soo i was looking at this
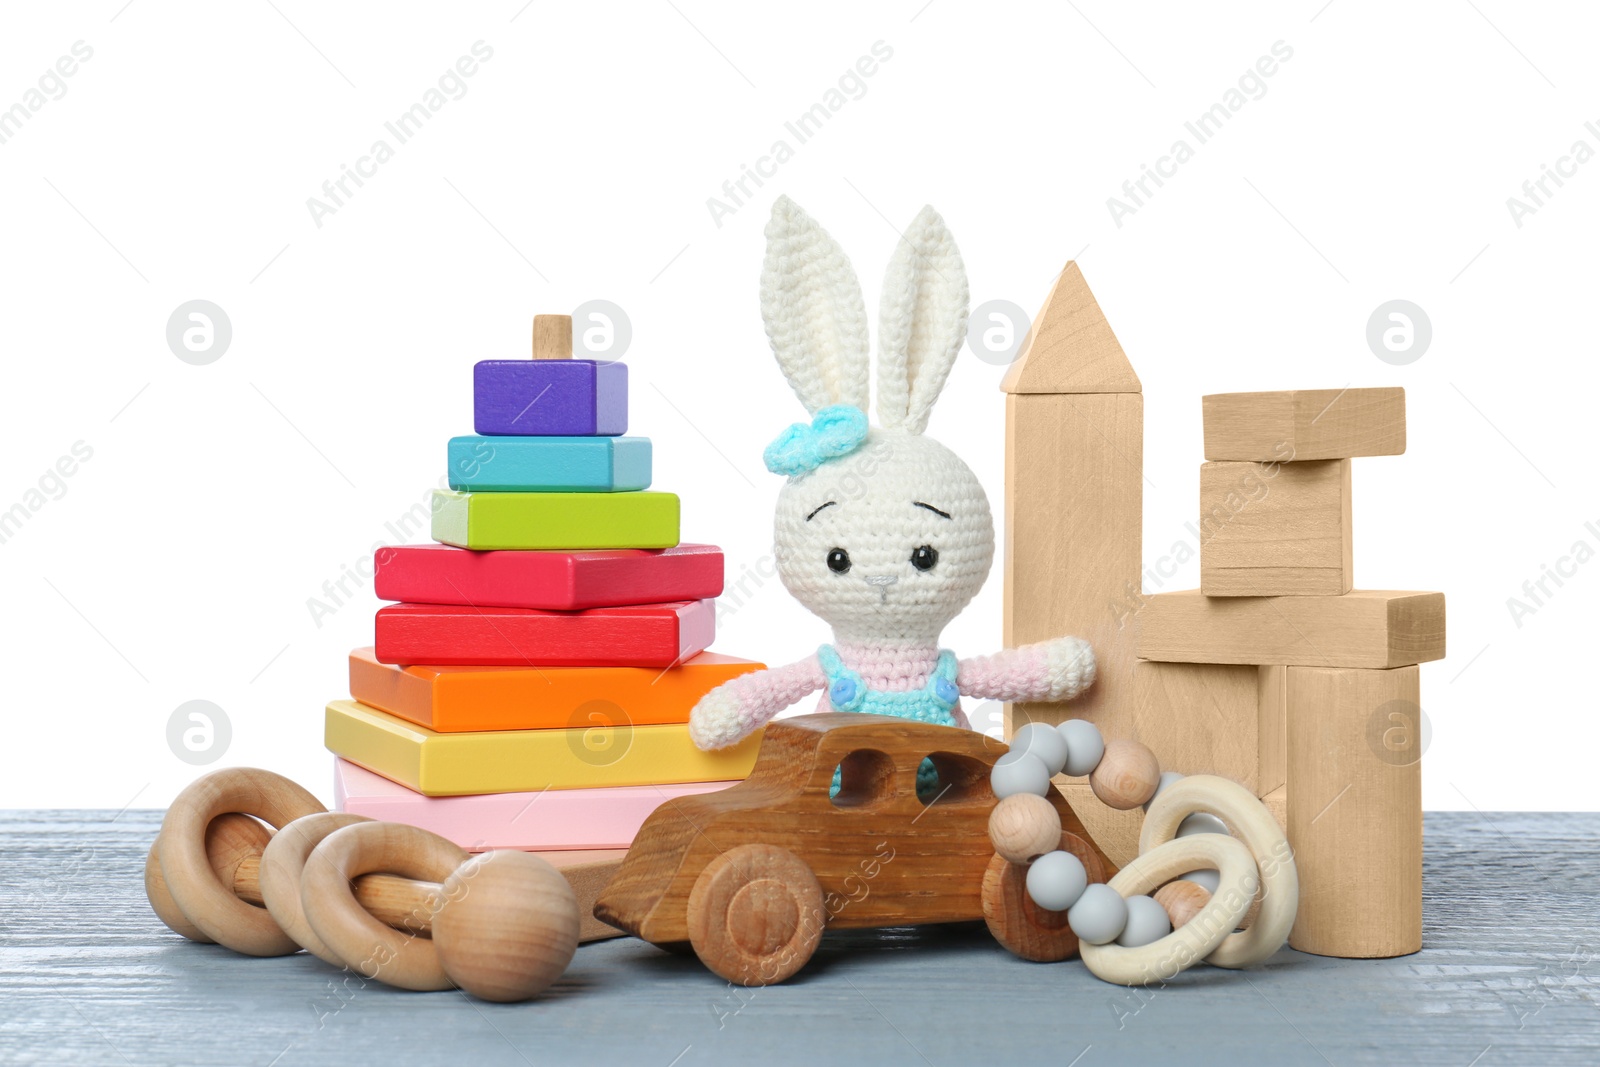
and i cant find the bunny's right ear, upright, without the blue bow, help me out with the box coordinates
[878,205,966,434]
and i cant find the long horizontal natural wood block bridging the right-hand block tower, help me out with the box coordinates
[1139,589,1445,667]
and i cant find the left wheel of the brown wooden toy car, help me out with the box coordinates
[688,845,826,985]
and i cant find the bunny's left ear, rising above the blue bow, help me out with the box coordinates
[762,197,867,414]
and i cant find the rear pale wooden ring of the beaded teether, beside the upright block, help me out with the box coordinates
[1139,774,1299,968]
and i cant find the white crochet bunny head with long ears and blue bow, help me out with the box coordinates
[762,197,994,646]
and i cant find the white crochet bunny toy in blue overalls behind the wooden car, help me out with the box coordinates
[690,197,1094,758]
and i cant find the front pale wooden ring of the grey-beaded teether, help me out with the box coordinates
[1078,833,1259,985]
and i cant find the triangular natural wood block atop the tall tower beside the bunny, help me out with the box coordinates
[1000,262,1141,394]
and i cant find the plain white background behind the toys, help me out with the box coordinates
[0,0,1600,811]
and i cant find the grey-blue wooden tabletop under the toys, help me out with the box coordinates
[0,811,1600,1067]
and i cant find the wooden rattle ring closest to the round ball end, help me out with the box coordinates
[301,822,469,990]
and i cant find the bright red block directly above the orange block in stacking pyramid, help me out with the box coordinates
[374,600,717,667]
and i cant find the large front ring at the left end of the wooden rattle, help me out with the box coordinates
[155,768,323,957]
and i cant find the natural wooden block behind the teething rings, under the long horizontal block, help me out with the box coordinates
[1126,659,1262,797]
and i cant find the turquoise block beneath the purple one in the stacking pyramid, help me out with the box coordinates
[445,437,651,493]
